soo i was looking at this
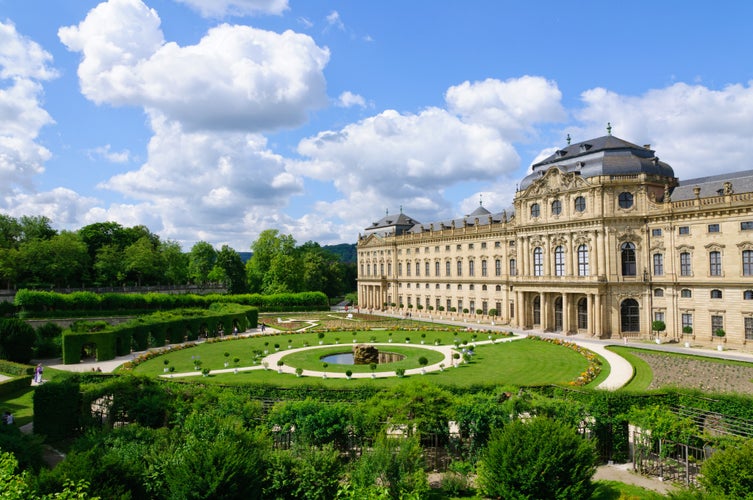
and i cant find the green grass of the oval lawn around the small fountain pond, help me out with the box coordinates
[134,331,592,388]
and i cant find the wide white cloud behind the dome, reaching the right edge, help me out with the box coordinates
[571,83,753,180]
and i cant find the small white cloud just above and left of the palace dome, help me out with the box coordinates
[445,76,567,140]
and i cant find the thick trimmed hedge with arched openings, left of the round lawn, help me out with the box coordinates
[63,304,259,364]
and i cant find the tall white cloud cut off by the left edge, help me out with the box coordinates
[0,22,57,199]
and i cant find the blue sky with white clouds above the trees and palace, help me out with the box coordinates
[0,0,753,251]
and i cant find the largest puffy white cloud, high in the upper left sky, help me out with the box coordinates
[58,0,329,132]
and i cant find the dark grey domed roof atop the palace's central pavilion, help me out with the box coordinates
[520,135,675,189]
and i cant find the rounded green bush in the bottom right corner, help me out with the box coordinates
[699,439,753,500]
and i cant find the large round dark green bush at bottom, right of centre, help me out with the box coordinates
[478,417,597,499]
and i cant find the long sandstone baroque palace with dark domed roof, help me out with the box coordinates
[358,129,753,345]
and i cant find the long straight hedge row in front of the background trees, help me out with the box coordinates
[14,289,329,317]
